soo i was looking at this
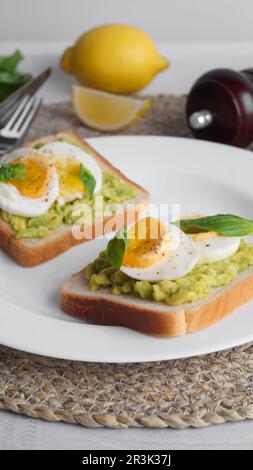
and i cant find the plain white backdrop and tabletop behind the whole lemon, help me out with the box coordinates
[0,0,253,102]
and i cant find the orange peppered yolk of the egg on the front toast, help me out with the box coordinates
[123,217,172,268]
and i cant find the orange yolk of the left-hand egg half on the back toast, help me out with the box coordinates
[10,152,53,199]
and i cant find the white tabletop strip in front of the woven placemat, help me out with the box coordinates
[0,411,253,450]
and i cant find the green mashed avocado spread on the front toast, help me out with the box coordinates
[84,241,253,306]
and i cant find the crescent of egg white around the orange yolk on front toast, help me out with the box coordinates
[120,227,199,282]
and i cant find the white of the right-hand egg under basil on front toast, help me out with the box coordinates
[195,236,241,263]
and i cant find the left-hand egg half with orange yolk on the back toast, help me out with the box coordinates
[0,148,59,217]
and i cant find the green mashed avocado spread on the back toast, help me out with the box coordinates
[0,138,135,239]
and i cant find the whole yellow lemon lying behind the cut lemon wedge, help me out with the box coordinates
[61,24,169,94]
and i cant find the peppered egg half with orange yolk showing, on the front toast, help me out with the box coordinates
[120,217,199,282]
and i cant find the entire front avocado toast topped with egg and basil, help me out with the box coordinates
[60,214,253,336]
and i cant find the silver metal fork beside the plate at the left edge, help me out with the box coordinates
[0,95,42,157]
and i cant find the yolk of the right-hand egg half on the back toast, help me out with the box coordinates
[51,157,84,199]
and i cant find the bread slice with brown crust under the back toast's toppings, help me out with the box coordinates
[0,132,149,267]
